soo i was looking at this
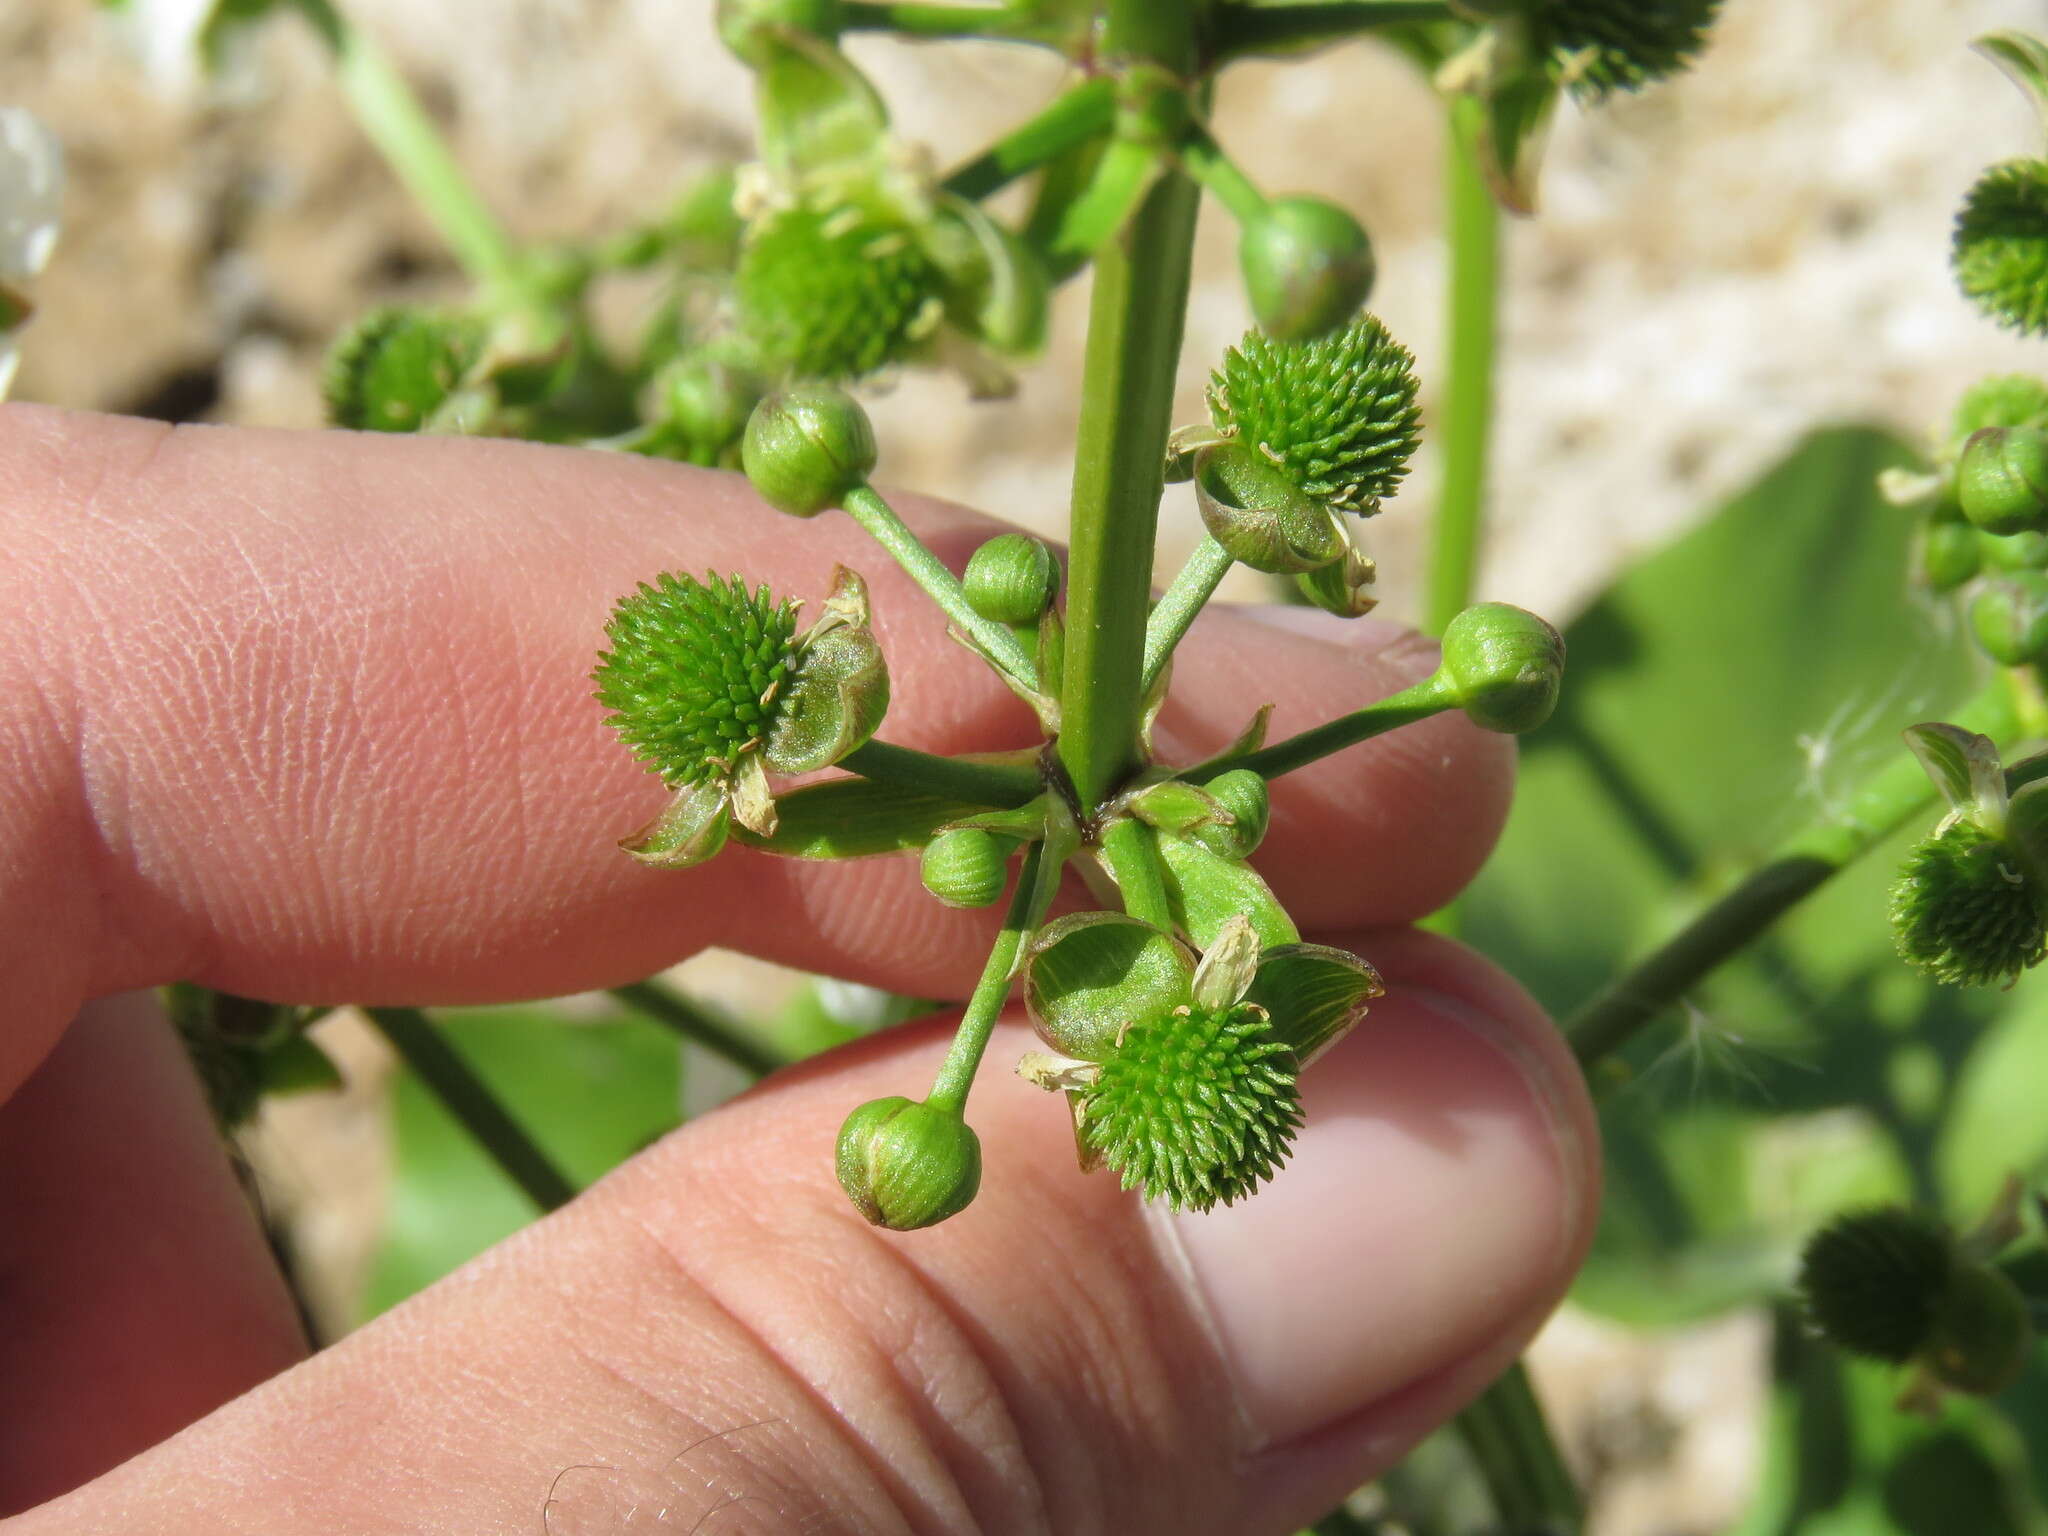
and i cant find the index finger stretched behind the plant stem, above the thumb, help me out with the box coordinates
[0,406,1511,1094]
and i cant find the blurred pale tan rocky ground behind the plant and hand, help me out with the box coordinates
[0,0,2048,1536]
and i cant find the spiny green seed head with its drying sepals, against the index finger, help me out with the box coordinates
[594,569,889,868]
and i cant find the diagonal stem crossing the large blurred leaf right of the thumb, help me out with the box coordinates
[1565,678,2019,1067]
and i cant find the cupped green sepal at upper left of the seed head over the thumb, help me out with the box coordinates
[1024,911,1196,1061]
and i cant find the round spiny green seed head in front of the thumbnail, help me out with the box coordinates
[1079,1006,1300,1210]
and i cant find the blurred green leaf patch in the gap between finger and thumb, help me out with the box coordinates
[362,1004,682,1317]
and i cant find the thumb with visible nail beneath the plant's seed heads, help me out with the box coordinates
[18,934,1597,1536]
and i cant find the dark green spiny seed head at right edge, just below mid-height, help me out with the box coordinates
[1890,821,2048,987]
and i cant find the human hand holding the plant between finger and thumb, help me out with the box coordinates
[0,408,1597,1536]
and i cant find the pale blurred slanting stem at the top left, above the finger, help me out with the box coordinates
[295,0,522,293]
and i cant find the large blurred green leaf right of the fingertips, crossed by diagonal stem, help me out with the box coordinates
[1464,430,2015,1323]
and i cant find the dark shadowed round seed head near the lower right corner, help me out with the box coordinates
[1798,1206,1954,1364]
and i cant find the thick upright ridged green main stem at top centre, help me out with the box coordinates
[1059,0,1206,811]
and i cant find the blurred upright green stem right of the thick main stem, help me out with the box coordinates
[1423,96,1501,635]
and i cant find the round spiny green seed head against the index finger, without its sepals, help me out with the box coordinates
[594,573,801,788]
